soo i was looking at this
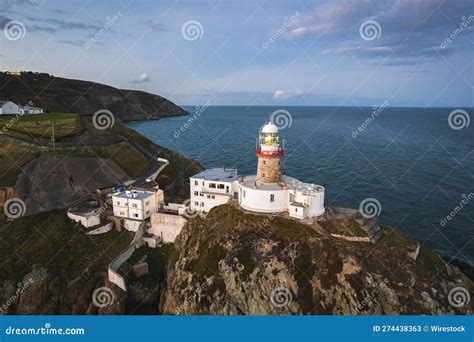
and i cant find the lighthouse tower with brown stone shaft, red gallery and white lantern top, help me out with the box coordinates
[256,122,283,183]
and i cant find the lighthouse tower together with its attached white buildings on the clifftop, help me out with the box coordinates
[190,122,324,219]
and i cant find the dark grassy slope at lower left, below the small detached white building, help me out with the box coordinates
[0,211,132,283]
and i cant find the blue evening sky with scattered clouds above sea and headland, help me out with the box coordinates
[0,0,474,107]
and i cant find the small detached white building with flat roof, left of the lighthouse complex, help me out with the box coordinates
[112,190,164,221]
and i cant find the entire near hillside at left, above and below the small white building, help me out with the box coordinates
[0,113,202,315]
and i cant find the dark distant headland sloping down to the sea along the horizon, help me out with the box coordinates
[0,72,187,122]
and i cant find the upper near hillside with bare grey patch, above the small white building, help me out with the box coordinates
[0,114,202,222]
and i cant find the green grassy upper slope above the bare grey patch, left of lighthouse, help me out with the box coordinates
[0,114,202,191]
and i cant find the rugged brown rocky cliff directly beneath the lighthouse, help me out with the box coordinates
[163,205,474,315]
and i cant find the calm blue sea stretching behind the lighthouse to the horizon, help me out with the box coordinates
[129,106,474,264]
